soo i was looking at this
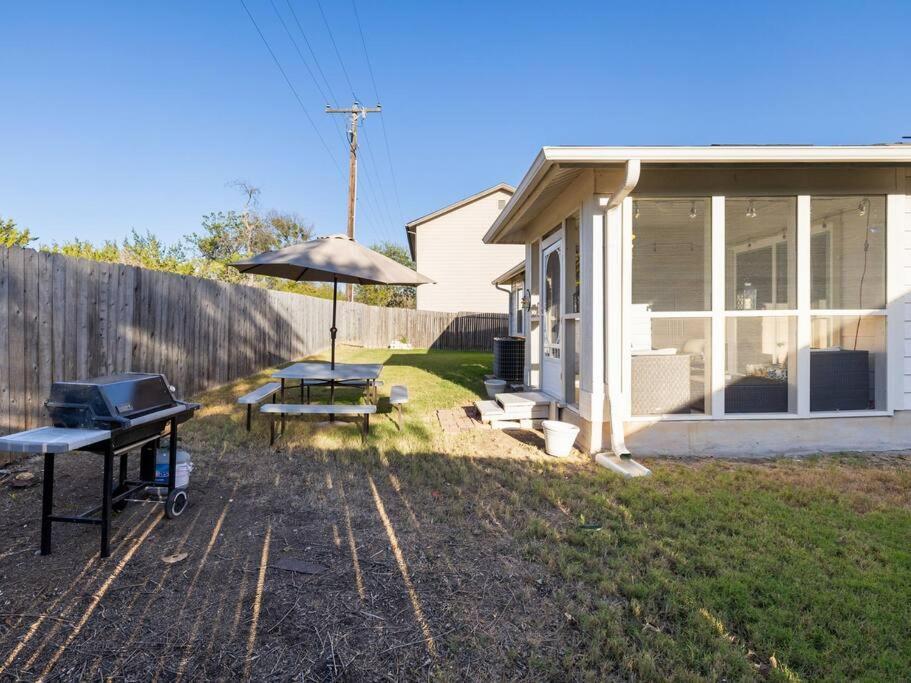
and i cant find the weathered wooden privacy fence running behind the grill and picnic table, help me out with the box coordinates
[0,247,507,434]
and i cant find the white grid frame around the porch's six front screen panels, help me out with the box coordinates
[621,194,896,422]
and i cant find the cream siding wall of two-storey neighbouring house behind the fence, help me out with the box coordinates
[415,192,525,313]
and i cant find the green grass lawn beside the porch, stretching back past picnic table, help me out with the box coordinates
[188,348,911,681]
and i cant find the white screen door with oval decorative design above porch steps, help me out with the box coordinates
[541,231,563,399]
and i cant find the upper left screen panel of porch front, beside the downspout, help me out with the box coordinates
[632,198,712,311]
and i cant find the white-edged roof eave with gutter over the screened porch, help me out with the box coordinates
[484,143,911,243]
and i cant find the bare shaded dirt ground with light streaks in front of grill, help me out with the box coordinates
[0,416,584,681]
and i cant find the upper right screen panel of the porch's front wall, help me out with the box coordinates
[810,196,886,309]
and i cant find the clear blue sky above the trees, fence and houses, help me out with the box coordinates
[0,0,911,252]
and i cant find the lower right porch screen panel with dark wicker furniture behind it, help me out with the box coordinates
[810,315,886,411]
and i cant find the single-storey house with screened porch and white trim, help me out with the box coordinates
[484,144,911,455]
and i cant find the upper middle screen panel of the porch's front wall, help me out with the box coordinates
[724,197,797,311]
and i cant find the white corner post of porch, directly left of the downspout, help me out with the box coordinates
[579,197,605,453]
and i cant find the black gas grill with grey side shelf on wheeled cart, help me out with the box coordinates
[0,372,200,557]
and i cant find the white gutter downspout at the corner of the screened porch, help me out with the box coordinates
[598,159,642,460]
